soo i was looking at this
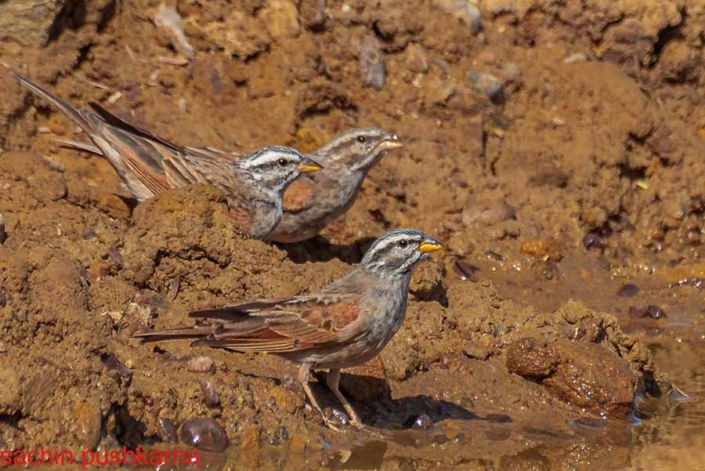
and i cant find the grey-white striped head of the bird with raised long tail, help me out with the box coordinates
[235,146,323,193]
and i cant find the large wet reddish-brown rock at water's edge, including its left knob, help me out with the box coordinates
[507,338,637,417]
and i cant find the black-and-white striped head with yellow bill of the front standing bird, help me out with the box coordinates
[360,229,443,278]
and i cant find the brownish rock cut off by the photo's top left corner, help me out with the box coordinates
[0,0,74,47]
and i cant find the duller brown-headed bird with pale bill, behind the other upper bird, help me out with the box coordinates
[268,128,403,243]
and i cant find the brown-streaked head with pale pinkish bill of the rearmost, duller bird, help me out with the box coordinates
[314,128,402,172]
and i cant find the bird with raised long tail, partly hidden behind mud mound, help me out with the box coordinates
[11,72,323,239]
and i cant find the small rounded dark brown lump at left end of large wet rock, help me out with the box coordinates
[507,337,560,379]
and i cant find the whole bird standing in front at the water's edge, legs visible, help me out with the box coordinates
[133,229,444,429]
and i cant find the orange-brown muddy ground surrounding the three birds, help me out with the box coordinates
[0,0,705,470]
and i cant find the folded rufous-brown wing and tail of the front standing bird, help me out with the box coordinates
[138,295,360,353]
